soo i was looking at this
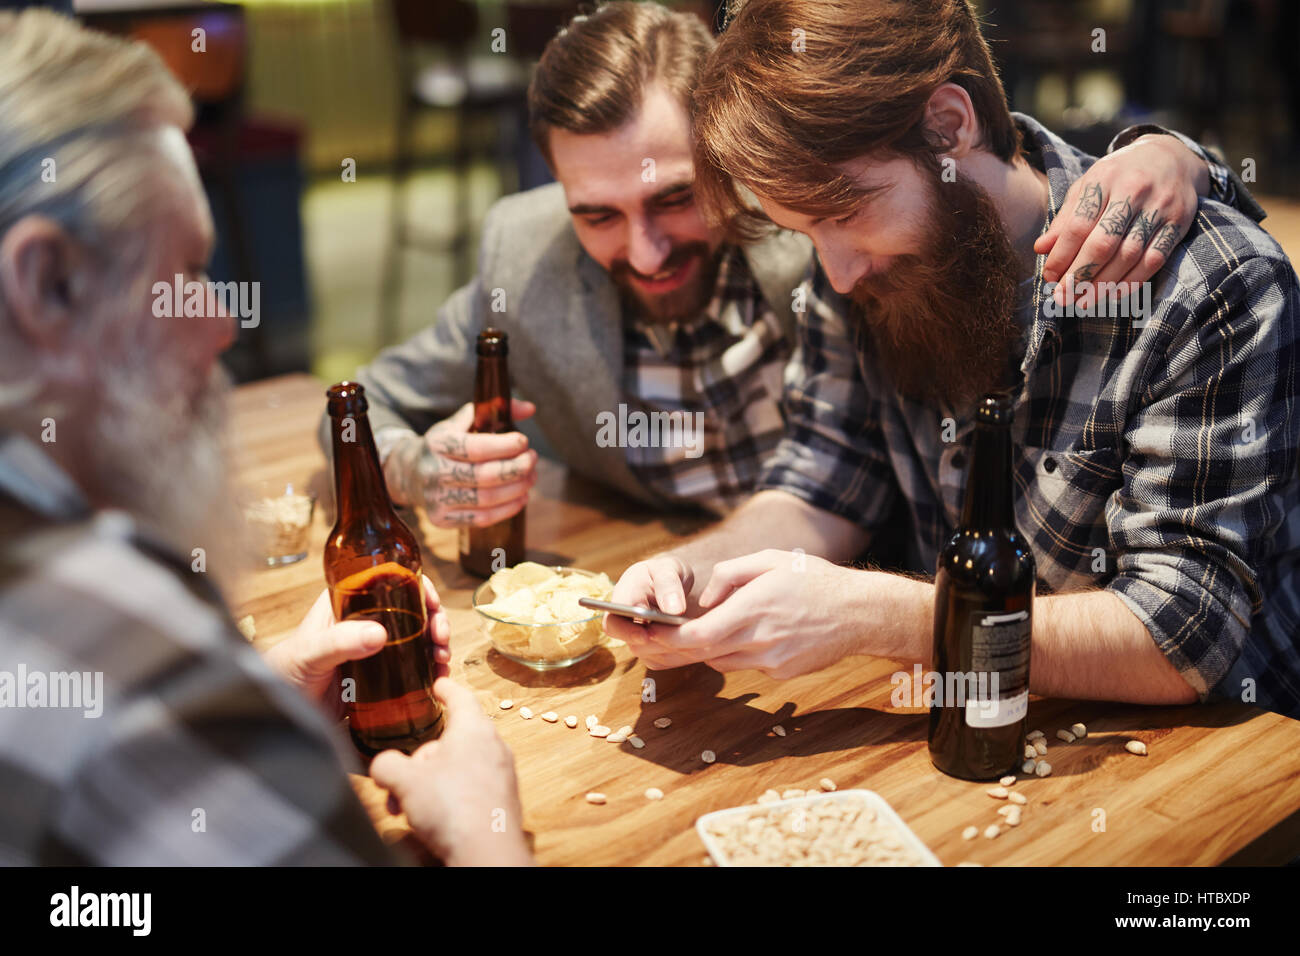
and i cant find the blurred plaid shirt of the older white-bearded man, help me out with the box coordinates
[0,433,394,866]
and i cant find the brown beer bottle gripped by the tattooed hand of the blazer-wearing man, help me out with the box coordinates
[460,329,525,578]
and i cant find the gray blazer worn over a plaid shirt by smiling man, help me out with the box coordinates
[321,183,813,507]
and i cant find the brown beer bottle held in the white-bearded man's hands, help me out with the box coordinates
[325,382,442,757]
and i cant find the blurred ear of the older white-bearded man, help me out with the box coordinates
[0,216,83,349]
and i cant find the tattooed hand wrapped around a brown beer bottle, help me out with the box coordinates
[384,398,537,528]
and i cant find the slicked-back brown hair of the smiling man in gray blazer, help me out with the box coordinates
[528,0,714,164]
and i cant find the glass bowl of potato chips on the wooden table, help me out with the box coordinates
[473,561,614,670]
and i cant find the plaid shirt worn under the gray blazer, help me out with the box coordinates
[623,246,792,514]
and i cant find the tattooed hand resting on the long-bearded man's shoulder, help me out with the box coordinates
[1034,134,1209,307]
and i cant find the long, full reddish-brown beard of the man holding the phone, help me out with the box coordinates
[852,163,1021,410]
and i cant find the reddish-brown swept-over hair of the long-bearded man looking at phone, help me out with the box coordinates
[694,0,1021,239]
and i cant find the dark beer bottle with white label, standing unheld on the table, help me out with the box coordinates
[930,393,1035,780]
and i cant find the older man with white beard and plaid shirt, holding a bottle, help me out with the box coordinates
[0,12,530,865]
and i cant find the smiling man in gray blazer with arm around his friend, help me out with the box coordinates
[335,3,1248,527]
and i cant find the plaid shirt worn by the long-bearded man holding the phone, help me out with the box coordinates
[759,116,1300,718]
